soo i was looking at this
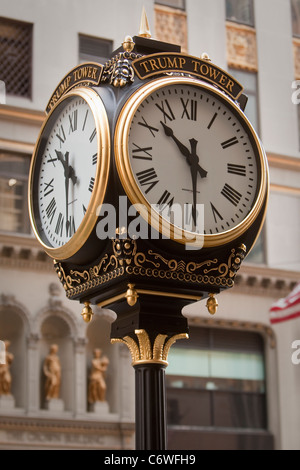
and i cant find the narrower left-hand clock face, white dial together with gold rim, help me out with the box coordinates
[30,89,109,259]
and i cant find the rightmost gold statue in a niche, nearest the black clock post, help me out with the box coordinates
[88,349,109,403]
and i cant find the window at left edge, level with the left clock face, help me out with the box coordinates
[0,151,30,233]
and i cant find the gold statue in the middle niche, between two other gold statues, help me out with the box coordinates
[43,344,61,401]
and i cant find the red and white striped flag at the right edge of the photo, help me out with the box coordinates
[270,282,300,324]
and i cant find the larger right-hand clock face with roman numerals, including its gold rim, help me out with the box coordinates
[117,78,263,245]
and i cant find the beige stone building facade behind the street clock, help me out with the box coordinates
[0,0,300,450]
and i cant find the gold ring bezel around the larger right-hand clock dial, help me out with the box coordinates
[114,77,269,248]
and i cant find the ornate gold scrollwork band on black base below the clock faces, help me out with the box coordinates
[54,241,246,301]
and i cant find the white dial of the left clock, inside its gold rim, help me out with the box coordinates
[38,97,98,247]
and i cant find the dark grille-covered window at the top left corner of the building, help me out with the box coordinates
[0,18,33,98]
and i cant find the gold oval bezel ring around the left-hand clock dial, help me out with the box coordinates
[28,87,110,260]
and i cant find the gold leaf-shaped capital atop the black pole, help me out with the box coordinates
[111,329,189,367]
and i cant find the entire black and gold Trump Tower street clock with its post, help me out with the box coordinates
[29,11,269,450]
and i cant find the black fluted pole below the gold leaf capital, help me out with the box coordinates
[134,363,167,450]
